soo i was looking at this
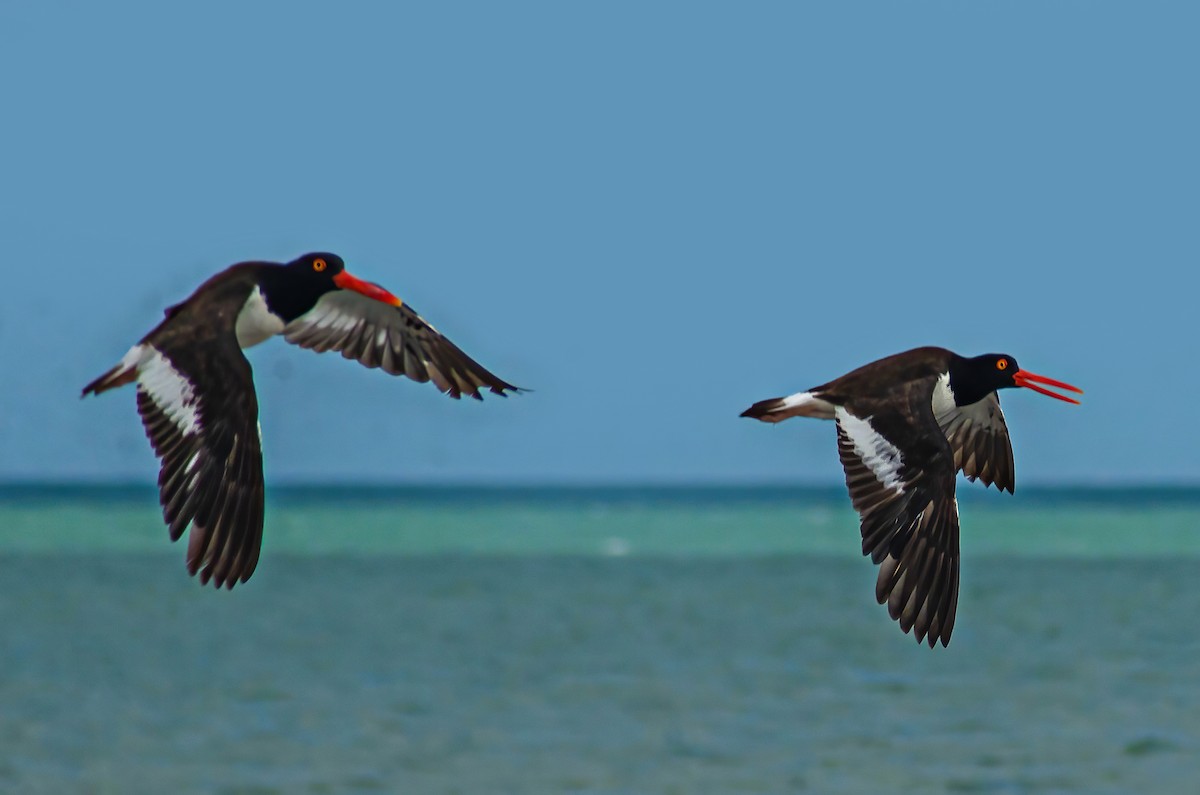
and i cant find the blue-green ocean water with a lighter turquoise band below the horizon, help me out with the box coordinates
[0,486,1200,795]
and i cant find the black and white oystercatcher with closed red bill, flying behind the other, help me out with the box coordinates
[83,253,520,588]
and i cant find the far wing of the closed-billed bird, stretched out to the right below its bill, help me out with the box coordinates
[283,289,517,400]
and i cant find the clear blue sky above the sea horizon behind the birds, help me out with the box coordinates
[0,1,1200,485]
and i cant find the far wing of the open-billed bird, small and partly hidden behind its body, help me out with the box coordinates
[936,393,1016,494]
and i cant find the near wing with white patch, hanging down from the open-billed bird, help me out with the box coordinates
[835,405,959,647]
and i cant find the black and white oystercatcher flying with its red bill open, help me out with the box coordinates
[742,347,1082,647]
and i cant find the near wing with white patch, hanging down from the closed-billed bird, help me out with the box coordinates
[138,324,263,588]
